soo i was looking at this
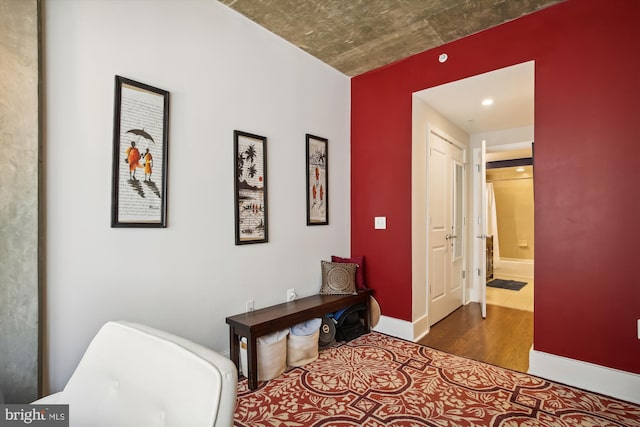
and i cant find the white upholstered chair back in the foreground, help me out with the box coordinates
[33,322,238,427]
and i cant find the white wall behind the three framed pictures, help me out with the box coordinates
[44,0,350,391]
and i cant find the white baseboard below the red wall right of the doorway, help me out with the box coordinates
[529,349,640,404]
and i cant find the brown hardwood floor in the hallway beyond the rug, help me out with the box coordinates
[419,303,533,372]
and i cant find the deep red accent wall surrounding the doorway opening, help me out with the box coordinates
[351,0,640,373]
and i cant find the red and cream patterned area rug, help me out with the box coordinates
[234,332,640,427]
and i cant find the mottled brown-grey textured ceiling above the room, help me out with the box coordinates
[220,0,563,76]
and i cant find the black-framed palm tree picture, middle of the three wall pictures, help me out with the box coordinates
[233,130,268,245]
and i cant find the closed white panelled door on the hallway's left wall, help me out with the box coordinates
[427,131,464,325]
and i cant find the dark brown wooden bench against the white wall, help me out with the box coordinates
[227,289,372,390]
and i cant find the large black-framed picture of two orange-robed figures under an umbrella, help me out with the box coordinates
[111,76,169,228]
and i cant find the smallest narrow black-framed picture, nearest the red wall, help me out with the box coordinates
[306,134,329,225]
